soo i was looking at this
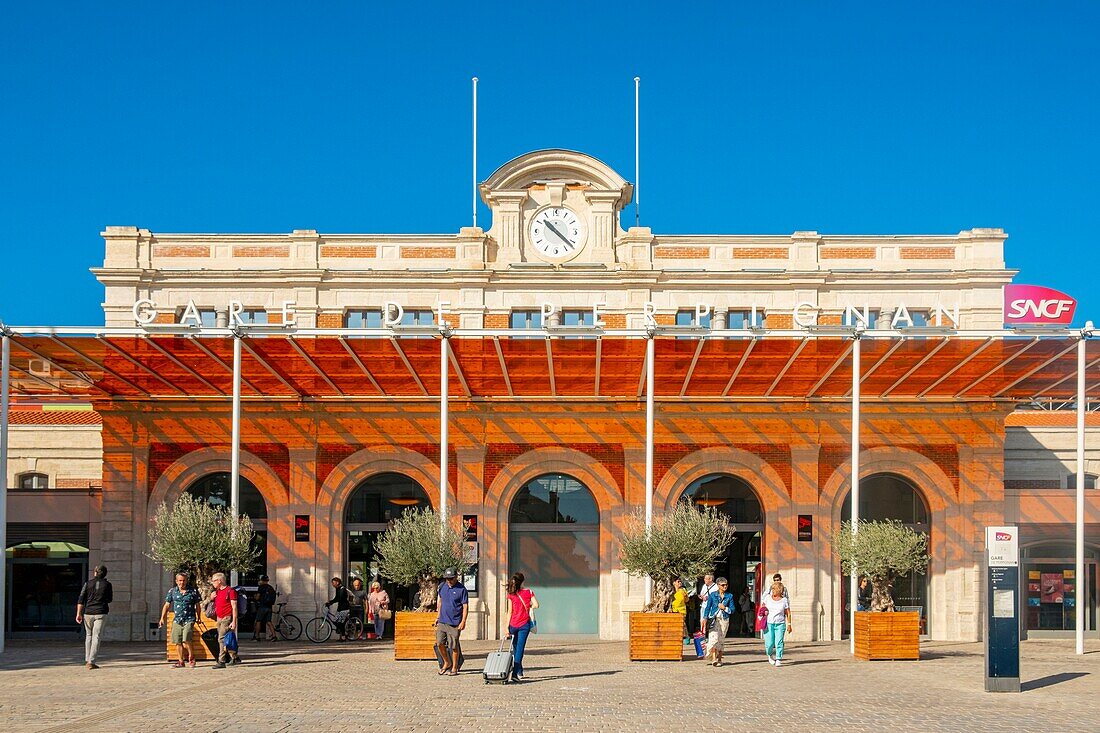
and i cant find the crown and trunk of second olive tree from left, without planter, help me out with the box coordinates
[374,508,470,611]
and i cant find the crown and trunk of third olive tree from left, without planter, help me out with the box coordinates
[619,501,736,612]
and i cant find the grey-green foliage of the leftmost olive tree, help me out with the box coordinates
[147,494,260,588]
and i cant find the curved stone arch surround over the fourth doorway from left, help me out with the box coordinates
[653,446,790,522]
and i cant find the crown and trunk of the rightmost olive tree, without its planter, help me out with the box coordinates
[833,519,931,611]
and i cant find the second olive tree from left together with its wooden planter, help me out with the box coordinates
[374,508,470,659]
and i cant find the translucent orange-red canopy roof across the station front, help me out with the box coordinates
[2,329,1100,402]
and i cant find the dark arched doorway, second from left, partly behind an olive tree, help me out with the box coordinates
[344,472,431,611]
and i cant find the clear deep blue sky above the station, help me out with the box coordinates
[0,1,1100,325]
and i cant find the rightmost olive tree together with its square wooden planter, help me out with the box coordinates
[833,519,931,659]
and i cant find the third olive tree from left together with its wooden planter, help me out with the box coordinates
[619,501,736,660]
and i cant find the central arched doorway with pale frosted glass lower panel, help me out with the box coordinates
[508,473,600,634]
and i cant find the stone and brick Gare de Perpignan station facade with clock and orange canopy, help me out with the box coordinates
[7,150,1100,641]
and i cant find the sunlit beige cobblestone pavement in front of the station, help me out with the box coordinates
[0,636,1100,733]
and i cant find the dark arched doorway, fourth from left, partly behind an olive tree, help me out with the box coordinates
[680,473,763,636]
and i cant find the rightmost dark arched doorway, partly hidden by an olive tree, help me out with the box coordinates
[840,473,932,635]
